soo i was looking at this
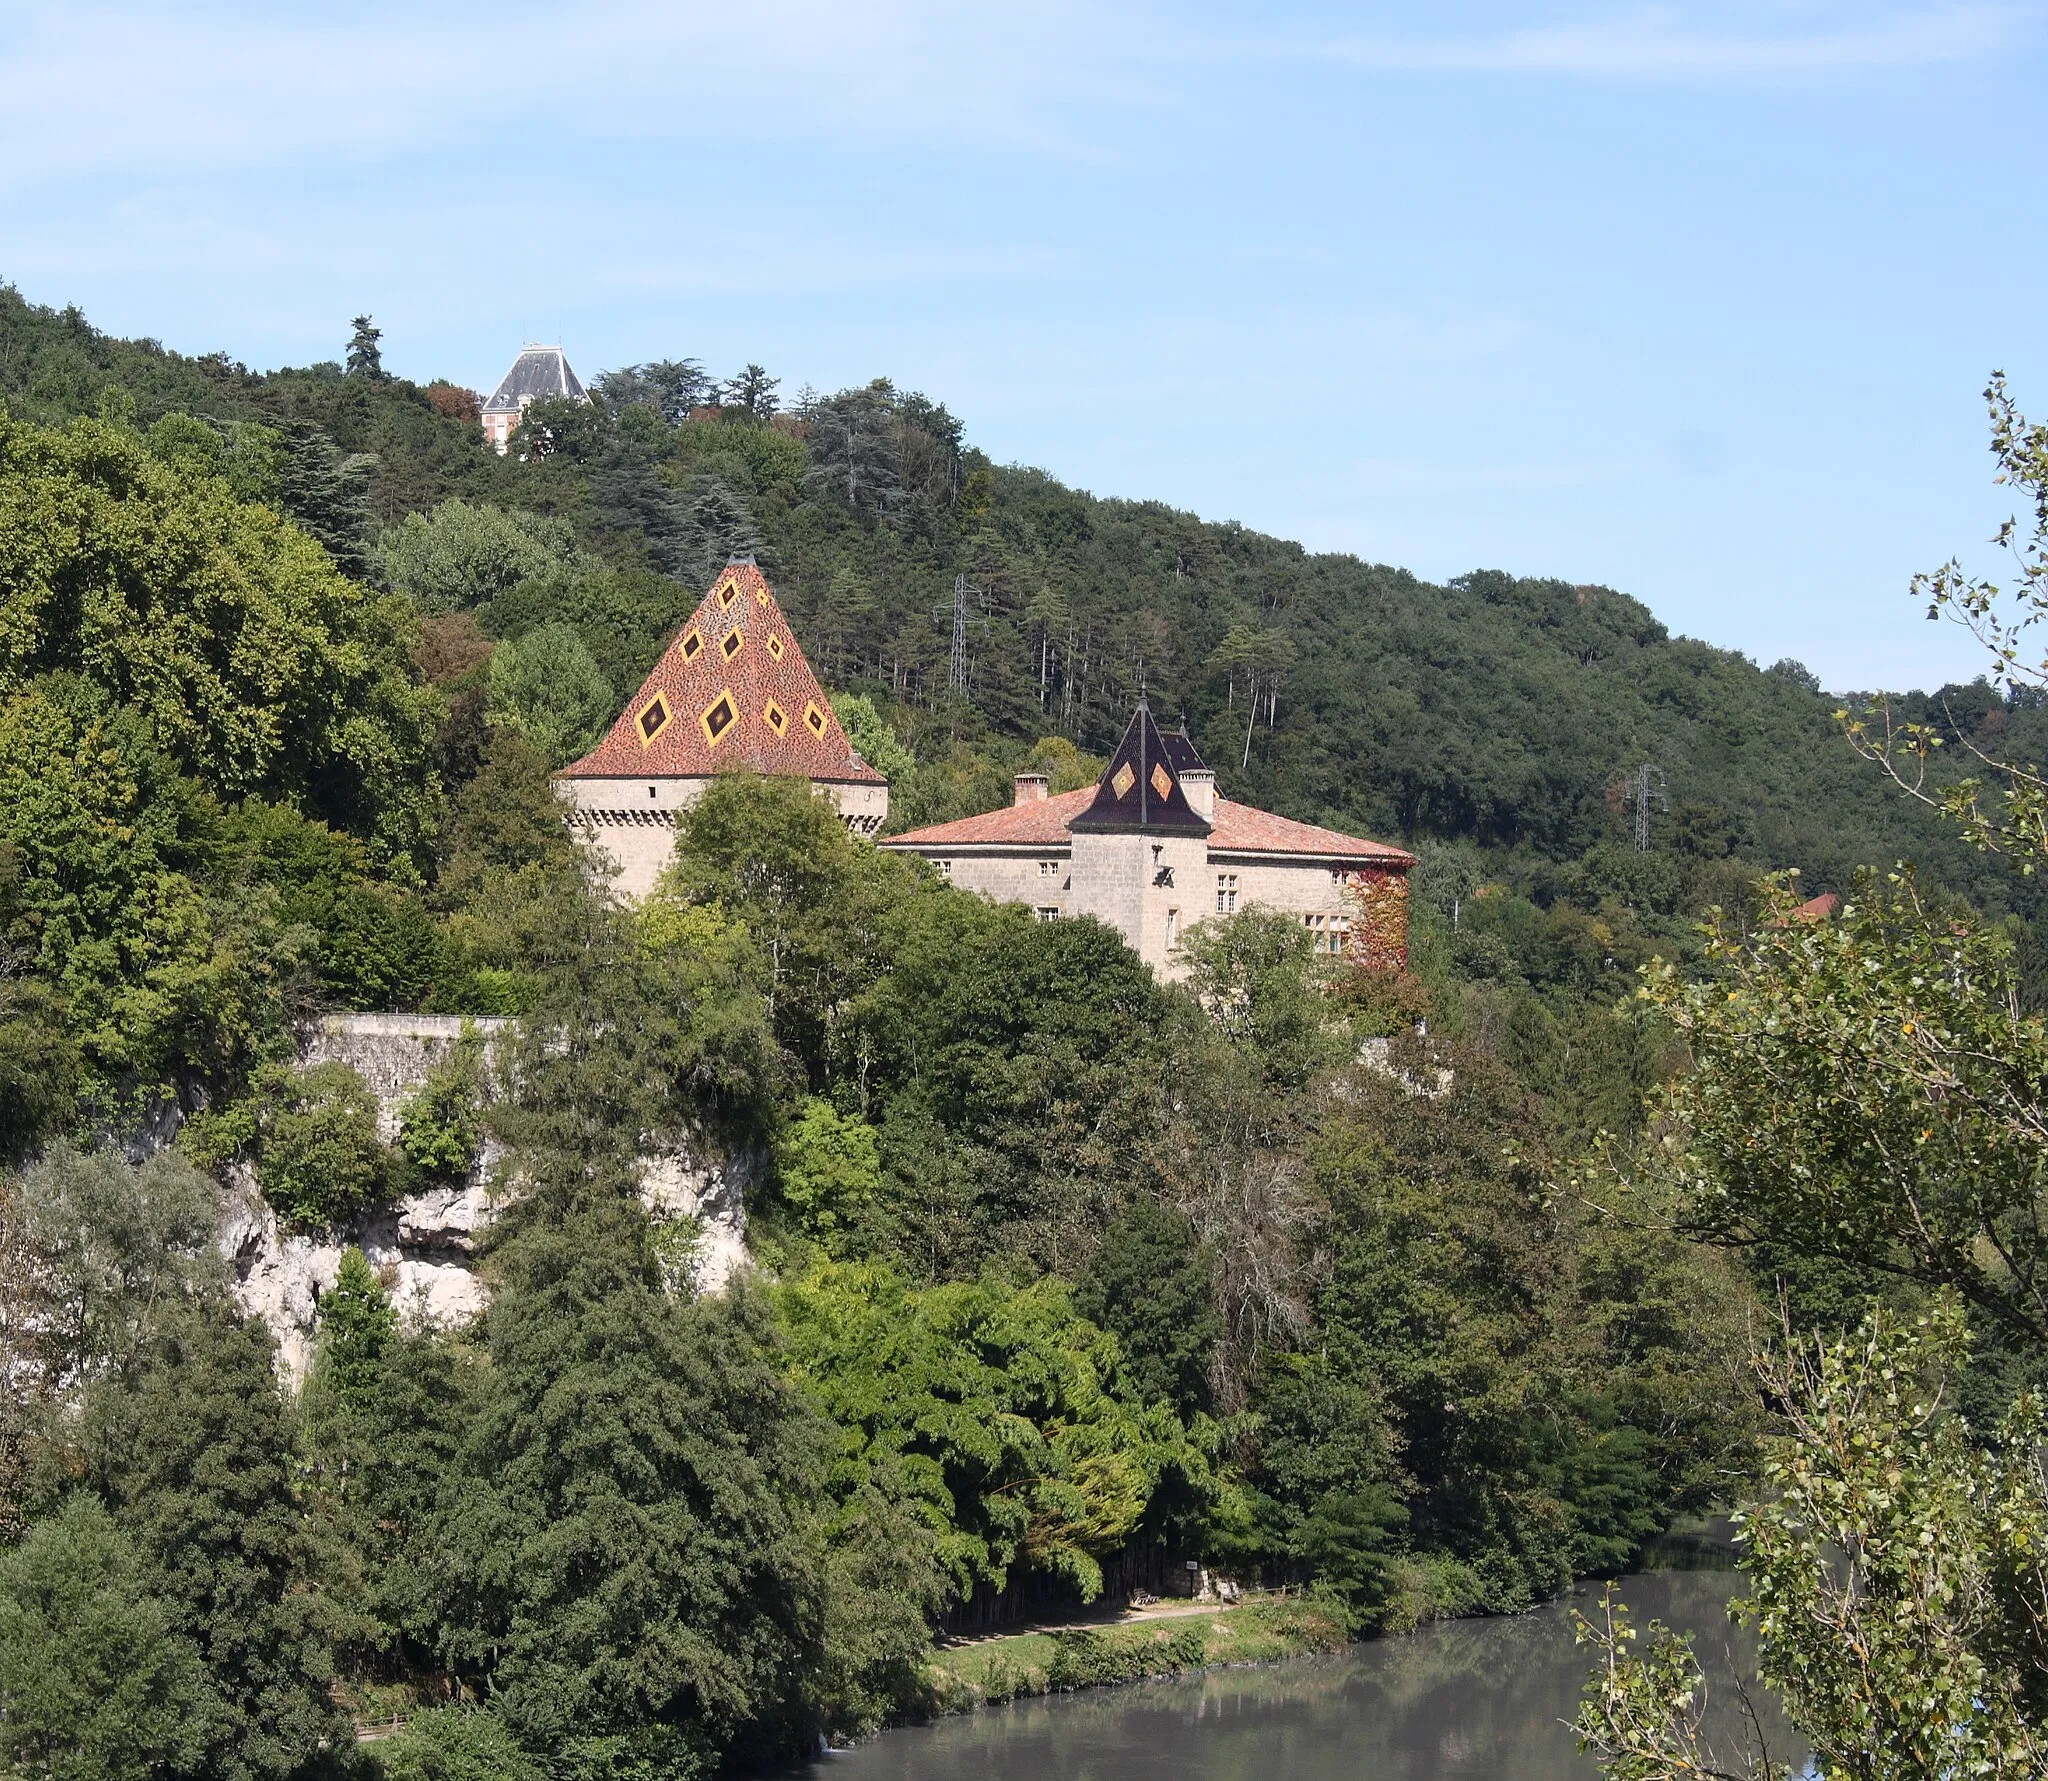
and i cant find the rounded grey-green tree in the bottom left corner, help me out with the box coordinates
[0,1492,219,1781]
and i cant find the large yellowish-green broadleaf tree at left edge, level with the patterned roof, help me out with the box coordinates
[0,405,438,868]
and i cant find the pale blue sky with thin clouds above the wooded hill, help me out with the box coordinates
[0,0,2048,690]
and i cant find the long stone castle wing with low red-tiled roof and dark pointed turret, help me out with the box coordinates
[881,700,1415,979]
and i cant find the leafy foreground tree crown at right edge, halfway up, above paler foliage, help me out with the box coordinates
[1642,876,2048,1347]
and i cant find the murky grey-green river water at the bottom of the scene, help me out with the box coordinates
[811,1570,1804,1781]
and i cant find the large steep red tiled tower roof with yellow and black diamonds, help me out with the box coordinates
[563,557,885,784]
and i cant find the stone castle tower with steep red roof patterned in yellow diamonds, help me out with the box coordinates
[559,557,889,897]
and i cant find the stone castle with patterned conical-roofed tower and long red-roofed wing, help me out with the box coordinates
[559,559,1415,976]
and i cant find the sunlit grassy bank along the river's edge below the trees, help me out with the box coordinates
[926,1599,1350,1713]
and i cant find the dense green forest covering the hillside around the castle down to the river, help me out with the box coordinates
[0,289,2044,1777]
